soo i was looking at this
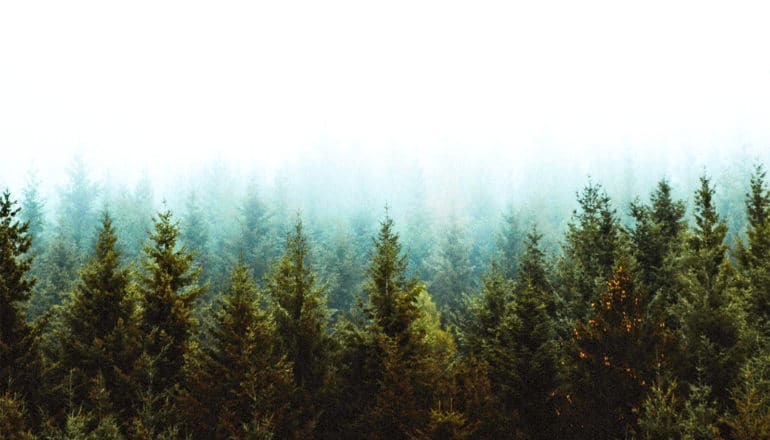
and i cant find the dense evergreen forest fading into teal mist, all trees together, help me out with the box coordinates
[0,162,770,439]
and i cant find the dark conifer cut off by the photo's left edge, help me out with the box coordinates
[0,191,44,422]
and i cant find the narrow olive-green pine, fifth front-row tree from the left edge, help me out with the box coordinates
[267,218,331,430]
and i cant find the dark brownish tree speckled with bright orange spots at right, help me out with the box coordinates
[570,258,666,438]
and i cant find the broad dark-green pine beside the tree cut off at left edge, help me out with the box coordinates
[59,212,139,422]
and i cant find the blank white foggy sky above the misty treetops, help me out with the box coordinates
[0,0,770,191]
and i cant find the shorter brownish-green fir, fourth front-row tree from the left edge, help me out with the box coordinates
[183,262,293,438]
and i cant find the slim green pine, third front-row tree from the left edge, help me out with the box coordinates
[139,210,203,394]
